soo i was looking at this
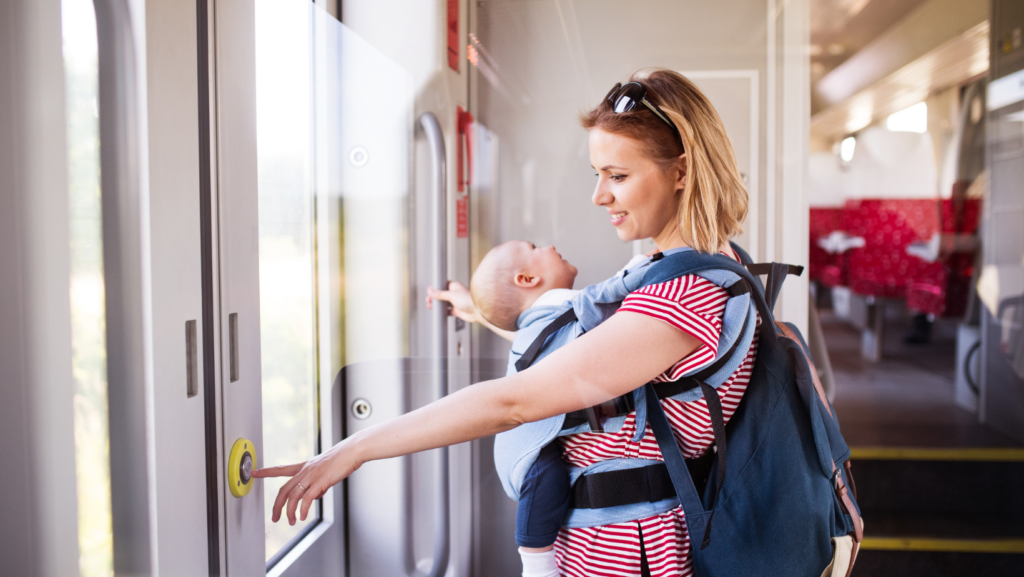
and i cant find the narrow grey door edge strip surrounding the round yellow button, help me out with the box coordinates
[211,0,266,576]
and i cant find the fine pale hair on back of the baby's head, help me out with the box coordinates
[469,241,524,331]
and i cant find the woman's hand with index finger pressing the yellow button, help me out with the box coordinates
[253,437,362,525]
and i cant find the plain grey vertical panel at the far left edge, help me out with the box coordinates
[0,0,79,577]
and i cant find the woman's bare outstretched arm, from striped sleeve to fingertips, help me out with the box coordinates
[254,312,699,525]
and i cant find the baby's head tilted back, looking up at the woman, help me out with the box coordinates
[469,241,577,331]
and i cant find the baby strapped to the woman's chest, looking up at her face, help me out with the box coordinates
[427,236,650,577]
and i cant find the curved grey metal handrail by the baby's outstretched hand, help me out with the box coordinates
[415,112,451,577]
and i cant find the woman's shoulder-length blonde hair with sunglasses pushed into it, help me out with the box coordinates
[580,69,748,254]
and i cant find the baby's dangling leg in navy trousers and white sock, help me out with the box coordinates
[515,443,569,577]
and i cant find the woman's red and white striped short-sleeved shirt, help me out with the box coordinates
[555,255,760,577]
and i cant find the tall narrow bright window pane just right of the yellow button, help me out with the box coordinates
[256,0,318,560]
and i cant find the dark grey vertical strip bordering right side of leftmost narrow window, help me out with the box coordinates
[93,0,157,575]
